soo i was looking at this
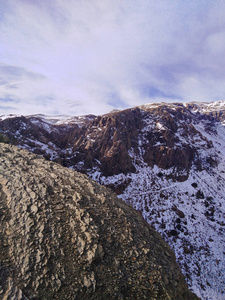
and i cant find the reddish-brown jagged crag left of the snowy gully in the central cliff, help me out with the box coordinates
[69,110,141,176]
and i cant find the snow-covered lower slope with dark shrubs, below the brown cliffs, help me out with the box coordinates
[93,150,225,300]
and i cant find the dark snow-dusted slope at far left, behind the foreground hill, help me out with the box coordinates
[0,115,89,164]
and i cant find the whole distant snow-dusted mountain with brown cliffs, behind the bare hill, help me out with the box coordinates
[0,101,225,299]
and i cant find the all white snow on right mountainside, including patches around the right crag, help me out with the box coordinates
[89,101,225,300]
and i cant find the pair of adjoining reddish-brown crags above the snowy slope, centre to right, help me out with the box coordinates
[68,104,203,180]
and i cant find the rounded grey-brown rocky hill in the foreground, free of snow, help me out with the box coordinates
[0,143,198,300]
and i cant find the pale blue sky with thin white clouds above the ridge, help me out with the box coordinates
[0,0,225,115]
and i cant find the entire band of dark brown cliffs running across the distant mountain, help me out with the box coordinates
[0,103,218,181]
